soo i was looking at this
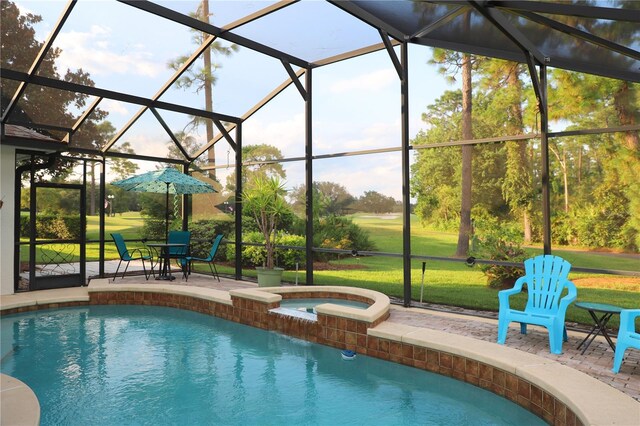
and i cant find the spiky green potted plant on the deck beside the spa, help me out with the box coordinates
[242,176,289,287]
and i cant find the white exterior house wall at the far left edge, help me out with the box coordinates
[0,145,16,295]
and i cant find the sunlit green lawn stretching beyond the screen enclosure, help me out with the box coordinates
[22,212,640,326]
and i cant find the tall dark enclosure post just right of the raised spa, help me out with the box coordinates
[400,40,411,306]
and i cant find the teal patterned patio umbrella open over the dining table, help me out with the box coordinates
[111,167,216,240]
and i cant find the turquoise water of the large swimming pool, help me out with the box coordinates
[0,306,544,426]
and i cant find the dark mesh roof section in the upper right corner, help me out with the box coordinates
[352,1,640,81]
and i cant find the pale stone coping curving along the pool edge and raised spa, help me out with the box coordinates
[0,280,640,425]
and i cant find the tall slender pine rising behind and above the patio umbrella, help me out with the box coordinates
[168,0,238,180]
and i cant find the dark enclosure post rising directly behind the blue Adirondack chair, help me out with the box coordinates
[540,64,551,254]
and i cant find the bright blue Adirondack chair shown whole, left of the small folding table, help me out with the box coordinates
[498,255,578,354]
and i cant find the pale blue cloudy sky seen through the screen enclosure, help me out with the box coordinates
[11,0,450,200]
